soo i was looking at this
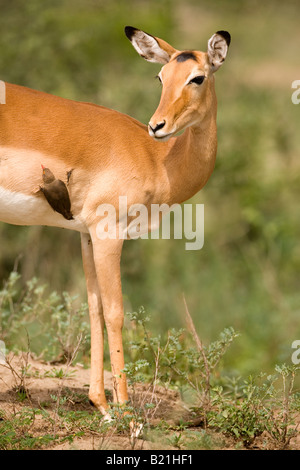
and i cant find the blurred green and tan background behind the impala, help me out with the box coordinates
[0,0,300,372]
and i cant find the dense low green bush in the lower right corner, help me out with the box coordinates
[208,364,300,449]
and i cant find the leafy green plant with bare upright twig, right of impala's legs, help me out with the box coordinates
[130,303,238,423]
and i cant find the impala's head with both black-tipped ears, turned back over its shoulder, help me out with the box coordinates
[125,26,230,141]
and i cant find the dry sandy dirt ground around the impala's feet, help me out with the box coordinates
[0,355,300,450]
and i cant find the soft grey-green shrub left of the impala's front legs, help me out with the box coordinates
[0,272,90,362]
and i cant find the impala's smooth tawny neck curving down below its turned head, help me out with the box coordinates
[165,111,217,204]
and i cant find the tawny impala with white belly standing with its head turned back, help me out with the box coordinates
[0,26,230,416]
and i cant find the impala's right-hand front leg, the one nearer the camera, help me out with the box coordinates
[91,230,128,403]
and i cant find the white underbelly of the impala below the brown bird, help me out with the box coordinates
[0,186,88,232]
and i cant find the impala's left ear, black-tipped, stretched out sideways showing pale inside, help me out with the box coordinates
[125,26,177,64]
